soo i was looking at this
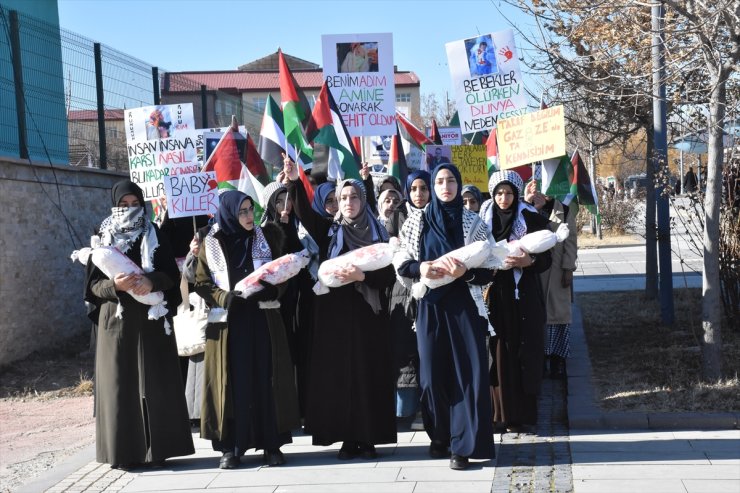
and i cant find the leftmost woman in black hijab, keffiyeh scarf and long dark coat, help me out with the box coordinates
[85,180,194,469]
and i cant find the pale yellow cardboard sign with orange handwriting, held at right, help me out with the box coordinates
[496,105,565,169]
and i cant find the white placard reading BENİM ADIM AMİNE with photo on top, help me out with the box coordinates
[321,33,396,137]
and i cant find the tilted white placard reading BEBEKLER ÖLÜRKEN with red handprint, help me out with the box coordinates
[445,29,527,134]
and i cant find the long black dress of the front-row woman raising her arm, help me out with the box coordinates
[288,181,396,445]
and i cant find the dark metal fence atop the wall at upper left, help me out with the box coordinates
[0,6,262,171]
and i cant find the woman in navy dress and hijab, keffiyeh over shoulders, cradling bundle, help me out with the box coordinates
[394,164,494,469]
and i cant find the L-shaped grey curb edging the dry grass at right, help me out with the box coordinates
[568,304,740,430]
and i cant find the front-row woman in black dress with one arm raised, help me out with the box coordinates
[284,159,396,460]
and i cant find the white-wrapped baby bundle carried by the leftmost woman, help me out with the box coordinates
[71,241,171,326]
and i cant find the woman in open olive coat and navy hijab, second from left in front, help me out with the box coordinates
[195,191,299,469]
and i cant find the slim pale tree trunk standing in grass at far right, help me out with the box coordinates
[701,68,729,381]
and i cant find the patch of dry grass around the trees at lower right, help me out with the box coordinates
[576,289,740,412]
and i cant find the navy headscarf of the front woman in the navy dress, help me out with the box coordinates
[419,163,465,261]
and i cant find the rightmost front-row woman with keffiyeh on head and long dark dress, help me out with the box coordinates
[480,170,550,432]
